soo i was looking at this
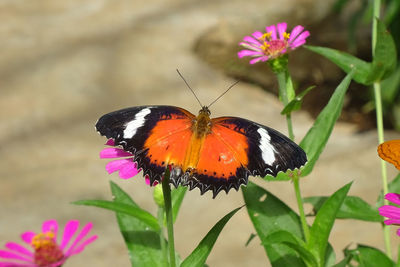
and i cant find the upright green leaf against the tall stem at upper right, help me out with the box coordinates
[372,19,397,80]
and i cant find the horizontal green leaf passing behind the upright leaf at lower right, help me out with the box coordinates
[304,196,382,222]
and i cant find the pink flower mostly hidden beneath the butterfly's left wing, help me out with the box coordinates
[100,139,150,185]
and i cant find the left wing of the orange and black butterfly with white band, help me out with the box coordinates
[96,106,195,184]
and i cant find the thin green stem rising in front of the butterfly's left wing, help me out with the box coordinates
[162,167,176,267]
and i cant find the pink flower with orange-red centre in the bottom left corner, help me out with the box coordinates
[0,220,97,267]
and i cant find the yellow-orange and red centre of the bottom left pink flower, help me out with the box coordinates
[31,231,64,267]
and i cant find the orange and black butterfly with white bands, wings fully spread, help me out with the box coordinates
[96,106,307,198]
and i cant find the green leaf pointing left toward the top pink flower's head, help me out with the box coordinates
[305,45,378,85]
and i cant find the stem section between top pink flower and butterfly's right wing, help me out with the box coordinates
[276,69,294,140]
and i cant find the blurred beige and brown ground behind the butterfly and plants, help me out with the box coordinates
[0,0,400,267]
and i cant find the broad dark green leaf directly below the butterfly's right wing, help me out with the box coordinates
[242,182,305,267]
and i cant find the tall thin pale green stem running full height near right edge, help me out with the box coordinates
[372,0,392,258]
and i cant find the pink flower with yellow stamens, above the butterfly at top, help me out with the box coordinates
[238,22,310,64]
